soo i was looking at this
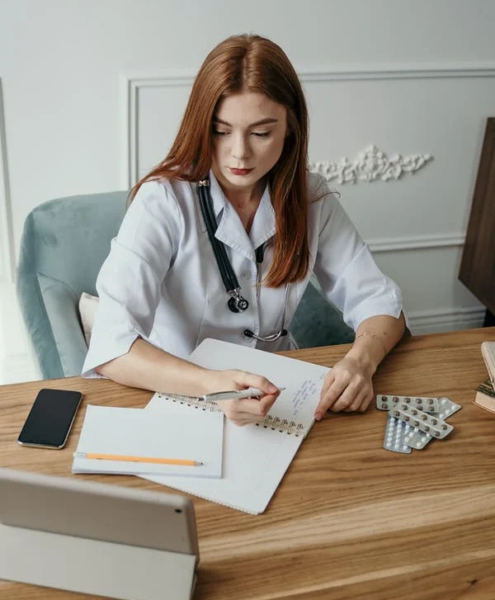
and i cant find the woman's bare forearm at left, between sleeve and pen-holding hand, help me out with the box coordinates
[97,338,211,396]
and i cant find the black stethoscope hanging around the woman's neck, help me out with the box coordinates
[198,177,289,342]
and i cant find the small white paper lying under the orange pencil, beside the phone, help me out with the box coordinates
[72,403,224,478]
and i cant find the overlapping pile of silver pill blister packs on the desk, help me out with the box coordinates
[376,394,461,454]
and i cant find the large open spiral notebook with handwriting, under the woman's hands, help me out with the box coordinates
[142,339,329,514]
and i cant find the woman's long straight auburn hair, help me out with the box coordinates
[131,35,309,287]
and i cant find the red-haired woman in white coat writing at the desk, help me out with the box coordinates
[83,35,404,425]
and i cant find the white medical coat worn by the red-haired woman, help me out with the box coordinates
[83,172,402,377]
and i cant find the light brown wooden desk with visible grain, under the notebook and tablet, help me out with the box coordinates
[0,328,495,600]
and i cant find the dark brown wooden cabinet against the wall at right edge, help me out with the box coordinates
[459,117,495,325]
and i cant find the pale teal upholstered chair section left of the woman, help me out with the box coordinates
[17,192,127,379]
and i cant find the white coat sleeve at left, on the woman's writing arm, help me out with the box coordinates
[82,181,183,377]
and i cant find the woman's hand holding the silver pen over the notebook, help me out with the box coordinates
[206,369,280,425]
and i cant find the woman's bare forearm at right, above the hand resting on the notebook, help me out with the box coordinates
[347,313,405,375]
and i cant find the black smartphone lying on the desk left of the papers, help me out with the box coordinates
[17,389,82,449]
